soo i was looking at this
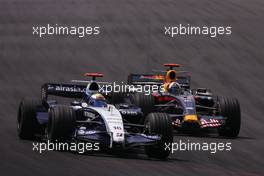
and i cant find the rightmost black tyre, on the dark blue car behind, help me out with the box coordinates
[218,98,241,138]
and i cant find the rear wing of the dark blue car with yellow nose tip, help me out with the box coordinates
[127,73,191,89]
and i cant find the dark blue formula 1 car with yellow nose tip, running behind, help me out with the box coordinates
[128,64,241,138]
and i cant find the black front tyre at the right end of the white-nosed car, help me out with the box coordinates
[145,113,173,159]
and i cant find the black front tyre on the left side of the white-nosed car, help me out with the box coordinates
[46,105,76,142]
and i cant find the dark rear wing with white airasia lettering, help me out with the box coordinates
[41,83,86,100]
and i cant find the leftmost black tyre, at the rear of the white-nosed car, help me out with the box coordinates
[17,98,42,140]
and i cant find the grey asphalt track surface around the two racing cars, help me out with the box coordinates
[0,0,264,176]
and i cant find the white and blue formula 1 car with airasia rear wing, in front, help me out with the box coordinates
[18,73,173,159]
